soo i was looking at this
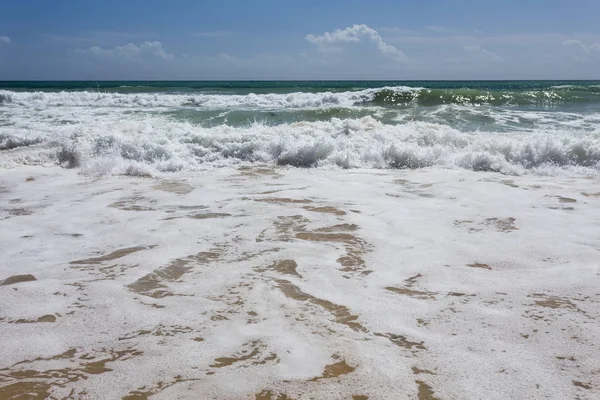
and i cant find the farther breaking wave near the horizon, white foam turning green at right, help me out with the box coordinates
[0,86,600,109]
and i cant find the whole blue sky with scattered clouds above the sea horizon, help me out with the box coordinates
[0,0,600,80]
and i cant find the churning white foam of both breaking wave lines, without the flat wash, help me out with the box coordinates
[0,87,600,175]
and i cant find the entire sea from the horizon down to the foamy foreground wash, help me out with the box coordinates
[0,81,600,400]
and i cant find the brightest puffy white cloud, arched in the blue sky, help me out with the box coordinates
[306,24,408,61]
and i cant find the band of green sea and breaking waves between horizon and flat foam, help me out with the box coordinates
[0,81,600,176]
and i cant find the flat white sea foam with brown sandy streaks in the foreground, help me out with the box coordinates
[0,166,600,400]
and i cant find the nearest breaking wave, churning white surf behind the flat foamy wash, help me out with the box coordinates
[0,115,600,176]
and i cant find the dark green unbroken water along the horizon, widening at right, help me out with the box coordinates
[0,81,600,108]
